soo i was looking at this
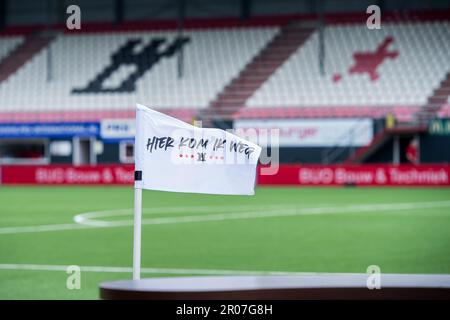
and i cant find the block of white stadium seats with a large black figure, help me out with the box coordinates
[0,27,277,112]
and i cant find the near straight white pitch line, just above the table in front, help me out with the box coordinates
[0,263,338,275]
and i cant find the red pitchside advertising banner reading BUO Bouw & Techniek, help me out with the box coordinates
[0,164,450,186]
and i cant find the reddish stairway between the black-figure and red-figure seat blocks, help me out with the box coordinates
[201,23,314,125]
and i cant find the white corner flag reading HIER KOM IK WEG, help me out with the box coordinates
[135,104,261,195]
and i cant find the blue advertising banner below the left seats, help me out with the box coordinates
[0,122,100,138]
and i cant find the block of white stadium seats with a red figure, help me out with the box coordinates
[246,22,450,108]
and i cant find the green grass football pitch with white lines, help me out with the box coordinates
[0,187,450,299]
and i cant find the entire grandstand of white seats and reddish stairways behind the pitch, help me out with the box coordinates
[0,1,450,168]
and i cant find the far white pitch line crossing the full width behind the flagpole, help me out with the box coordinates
[0,201,450,234]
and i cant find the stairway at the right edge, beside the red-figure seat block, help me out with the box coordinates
[416,72,450,125]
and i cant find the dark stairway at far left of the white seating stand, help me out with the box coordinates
[0,33,55,83]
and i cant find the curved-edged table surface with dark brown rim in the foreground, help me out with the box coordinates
[100,274,450,300]
